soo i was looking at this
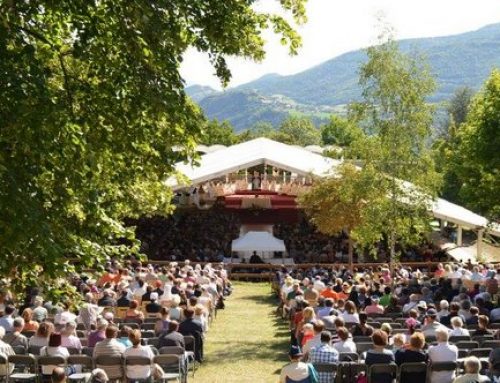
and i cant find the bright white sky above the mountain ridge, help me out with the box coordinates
[181,0,500,89]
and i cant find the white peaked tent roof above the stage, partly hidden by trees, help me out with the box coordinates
[167,137,500,236]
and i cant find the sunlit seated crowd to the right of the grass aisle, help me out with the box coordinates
[275,264,500,383]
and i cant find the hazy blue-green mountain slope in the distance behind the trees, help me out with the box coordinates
[187,23,500,130]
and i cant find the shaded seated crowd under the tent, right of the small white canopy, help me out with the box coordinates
[274,217,446,263]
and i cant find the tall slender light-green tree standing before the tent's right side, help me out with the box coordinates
[354,37,439,259]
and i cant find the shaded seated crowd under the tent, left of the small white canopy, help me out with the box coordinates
[133,208,240,262]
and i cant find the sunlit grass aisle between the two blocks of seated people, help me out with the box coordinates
[189,282,289,383]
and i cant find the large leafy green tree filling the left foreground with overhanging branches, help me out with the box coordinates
[0,0,305,298]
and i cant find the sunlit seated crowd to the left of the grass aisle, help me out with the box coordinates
[0,261,231,382]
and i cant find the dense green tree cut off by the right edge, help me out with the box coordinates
[449,69,500,220]
